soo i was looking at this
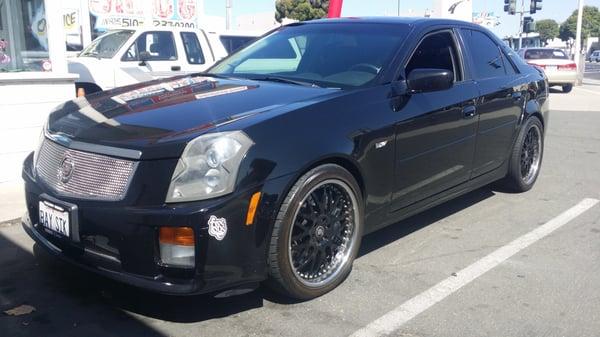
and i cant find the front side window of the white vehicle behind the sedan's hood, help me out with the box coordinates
[123,32,177,61]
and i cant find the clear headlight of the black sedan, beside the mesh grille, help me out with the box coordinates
[166,131,254,202]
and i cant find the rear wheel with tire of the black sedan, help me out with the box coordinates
[501,116,544,192]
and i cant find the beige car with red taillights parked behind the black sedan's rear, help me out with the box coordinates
[519,48,577,92]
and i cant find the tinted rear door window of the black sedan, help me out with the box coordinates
[462,29,506,79]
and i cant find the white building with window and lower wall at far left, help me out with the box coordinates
[0,0,76,183]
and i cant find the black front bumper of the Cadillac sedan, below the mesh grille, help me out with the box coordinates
[22,152,289,295]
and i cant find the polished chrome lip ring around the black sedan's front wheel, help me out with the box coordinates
[287,179,360,288]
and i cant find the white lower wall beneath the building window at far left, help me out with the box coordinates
[0,72,77,183]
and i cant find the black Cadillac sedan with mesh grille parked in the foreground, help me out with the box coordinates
[23,18,548,299]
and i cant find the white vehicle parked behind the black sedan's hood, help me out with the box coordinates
[68,27,227,93]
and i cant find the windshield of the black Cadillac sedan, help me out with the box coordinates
[209,23,409,88]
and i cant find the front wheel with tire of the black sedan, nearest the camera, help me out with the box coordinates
[267,164,364,300]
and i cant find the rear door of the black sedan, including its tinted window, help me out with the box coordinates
[461,29,526,177]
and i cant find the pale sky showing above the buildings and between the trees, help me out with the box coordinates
[204,0,600,37]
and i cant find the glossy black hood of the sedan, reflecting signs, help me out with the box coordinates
[47,75,339,159]
